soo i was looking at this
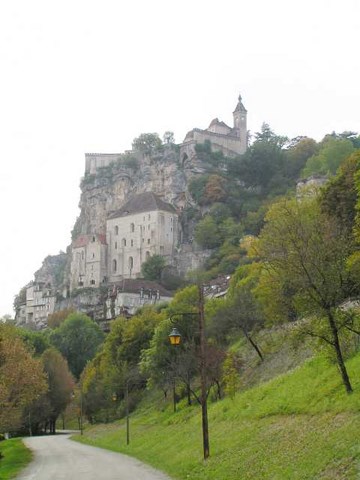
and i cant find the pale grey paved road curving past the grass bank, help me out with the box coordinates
[17,435,170,480]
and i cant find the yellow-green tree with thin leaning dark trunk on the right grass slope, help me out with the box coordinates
[258,198,354,393]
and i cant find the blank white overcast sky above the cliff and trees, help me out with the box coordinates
[0,0,360,317]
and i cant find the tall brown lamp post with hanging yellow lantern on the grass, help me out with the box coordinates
[169,285,210,460]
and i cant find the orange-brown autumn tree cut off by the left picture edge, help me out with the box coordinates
[0,325,47,432]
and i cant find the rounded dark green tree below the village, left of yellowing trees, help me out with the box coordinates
[50,313,104,378]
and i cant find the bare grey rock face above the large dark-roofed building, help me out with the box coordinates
[73,146,193,237]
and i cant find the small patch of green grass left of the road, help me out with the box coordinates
[0,438,32,480]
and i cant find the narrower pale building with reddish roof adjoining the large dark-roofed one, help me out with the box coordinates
[70,234,107,291]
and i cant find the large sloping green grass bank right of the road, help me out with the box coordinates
[74,354,360,480]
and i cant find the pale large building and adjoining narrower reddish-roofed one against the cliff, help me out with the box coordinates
[70,192,178,291]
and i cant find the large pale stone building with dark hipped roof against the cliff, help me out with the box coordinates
[106,192,178,283]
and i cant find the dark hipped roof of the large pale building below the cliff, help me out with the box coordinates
[108,192,176,219]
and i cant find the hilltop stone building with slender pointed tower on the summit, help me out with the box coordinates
[180,95,247,162]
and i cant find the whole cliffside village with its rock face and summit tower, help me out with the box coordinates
[16,96,248,328]
